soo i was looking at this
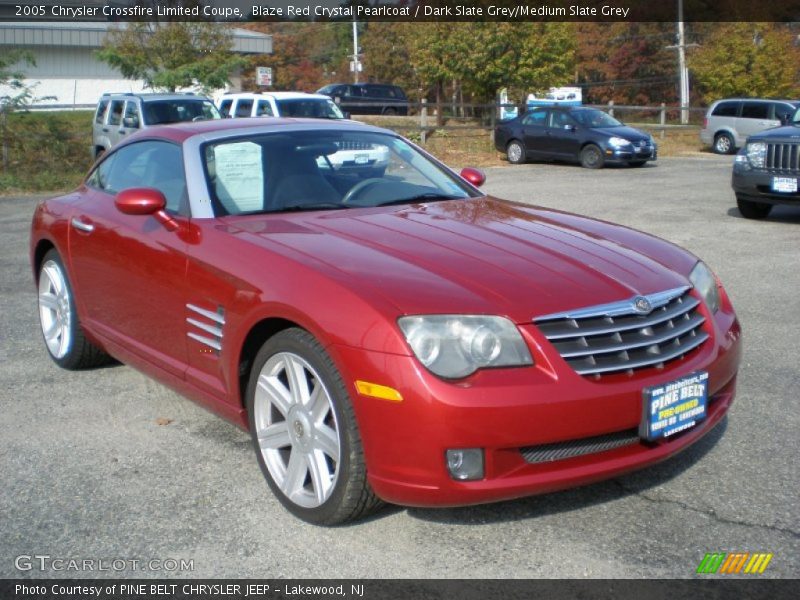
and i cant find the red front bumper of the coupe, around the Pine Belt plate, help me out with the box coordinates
[330,302,741,506]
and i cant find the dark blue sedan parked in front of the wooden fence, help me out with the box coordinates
[494,106,658,169]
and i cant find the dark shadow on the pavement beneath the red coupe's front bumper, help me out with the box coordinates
[404,417,728,525]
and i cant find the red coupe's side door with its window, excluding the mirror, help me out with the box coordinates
[69,140,187,377]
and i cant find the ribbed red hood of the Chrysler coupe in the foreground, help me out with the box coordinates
[226,197,696,323]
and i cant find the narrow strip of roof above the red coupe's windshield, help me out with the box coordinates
[119,117,396,146]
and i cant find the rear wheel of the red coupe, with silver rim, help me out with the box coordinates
[38,249,113,370]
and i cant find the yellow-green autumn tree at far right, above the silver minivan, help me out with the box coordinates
[689,23,800,102]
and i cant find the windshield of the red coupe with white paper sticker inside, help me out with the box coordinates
[201,129,479,215]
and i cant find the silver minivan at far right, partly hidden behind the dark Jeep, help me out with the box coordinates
[700,98,800,154]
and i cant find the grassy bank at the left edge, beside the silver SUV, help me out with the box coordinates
[0,111,93,194]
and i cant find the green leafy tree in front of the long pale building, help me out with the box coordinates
[97,22,248,93]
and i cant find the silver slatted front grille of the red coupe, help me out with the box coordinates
[534,287,708,375]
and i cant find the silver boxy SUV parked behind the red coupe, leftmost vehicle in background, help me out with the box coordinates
[92,93,220,159]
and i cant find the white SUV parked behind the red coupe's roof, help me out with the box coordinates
[219,92,346,119]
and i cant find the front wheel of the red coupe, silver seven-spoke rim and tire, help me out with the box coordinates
[247,328,380,525]
